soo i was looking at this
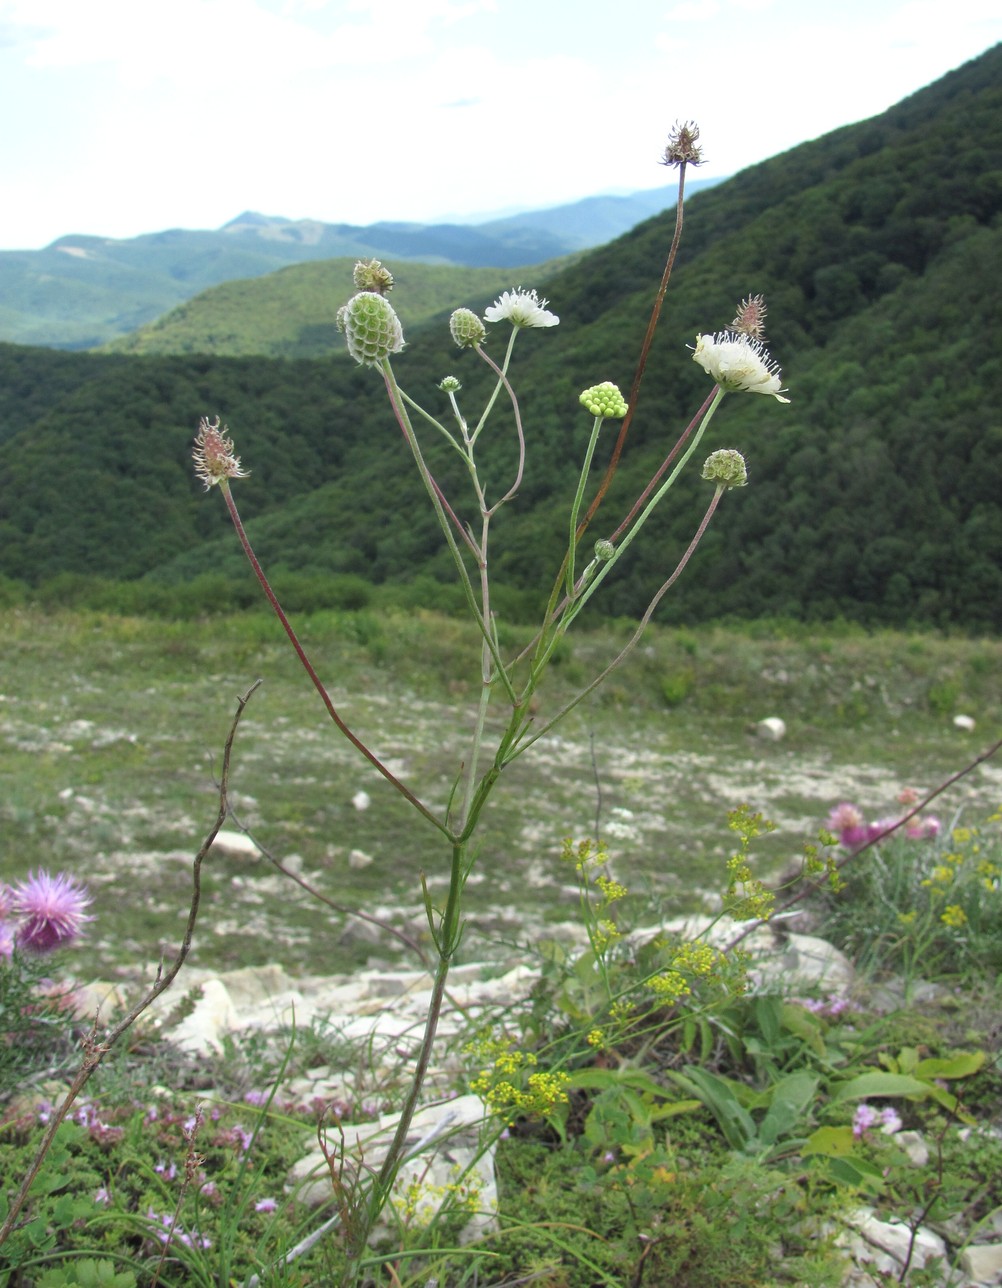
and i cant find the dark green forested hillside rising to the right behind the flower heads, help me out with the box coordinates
[0,46,1002,629]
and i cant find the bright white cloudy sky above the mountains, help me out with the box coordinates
[0,0,1002,250]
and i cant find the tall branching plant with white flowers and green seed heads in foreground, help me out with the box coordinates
[182,115,787,1283]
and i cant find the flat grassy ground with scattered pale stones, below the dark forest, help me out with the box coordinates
[0,612,1002,970]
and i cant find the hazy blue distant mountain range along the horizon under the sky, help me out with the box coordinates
[0,179,720,349]
